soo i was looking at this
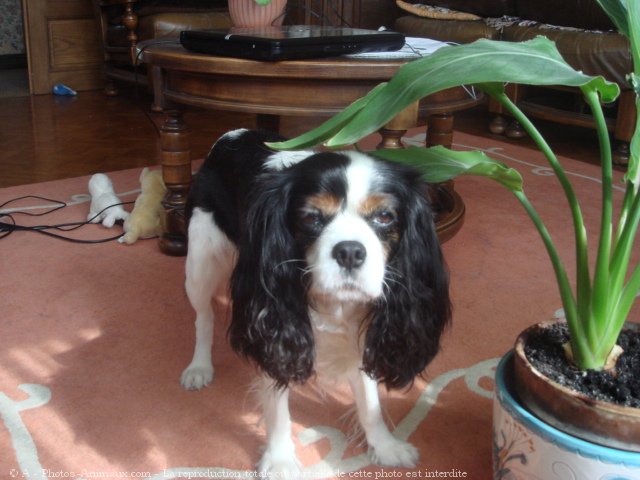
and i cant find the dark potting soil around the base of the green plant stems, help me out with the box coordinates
[525,324,640,408]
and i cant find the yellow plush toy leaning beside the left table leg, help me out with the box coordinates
[118,168,167,245]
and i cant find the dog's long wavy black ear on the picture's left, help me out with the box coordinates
[229,172,314,387]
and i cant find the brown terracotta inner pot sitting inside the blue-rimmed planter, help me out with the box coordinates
[514,323,640,457]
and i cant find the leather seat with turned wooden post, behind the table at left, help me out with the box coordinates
[93,0,231,95]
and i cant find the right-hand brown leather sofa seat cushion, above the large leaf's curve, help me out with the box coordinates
[502,24,632,89]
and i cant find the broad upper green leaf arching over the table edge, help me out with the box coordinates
[326,37,619,147]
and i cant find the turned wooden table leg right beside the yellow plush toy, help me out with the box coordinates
[160,110,191,256]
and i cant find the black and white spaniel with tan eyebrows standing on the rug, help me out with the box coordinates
[181,129,451,478]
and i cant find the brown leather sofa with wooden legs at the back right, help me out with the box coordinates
[388,0,636,164]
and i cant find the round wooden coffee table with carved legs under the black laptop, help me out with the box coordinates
[138,41,480,255]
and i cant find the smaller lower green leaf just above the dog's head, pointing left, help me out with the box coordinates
[369,146,522,191]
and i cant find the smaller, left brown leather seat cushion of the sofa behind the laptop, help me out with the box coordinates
[394,15,499,43]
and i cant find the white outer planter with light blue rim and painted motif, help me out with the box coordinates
[493,352,640,480]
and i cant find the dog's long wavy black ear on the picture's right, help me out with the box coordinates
[363,186,451,388]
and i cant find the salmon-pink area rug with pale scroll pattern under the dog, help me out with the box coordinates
[0,132,638,480]
